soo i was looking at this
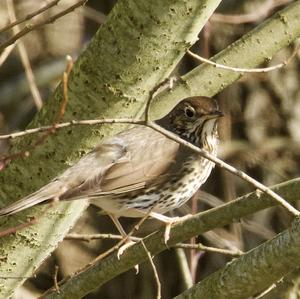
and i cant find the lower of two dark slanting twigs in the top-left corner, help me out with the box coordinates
[0,0,88,52]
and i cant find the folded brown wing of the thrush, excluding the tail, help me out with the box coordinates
[63,127,179,199]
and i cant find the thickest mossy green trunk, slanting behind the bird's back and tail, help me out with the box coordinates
[0,0,221,298]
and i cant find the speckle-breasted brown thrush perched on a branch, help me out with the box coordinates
[0,96,223,242]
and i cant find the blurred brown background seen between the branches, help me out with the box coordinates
[0,0,300,299]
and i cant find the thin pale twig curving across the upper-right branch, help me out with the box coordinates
[187,45,300,73]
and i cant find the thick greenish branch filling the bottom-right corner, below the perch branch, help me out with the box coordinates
[175,217,300,299]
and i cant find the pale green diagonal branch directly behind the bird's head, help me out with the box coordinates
[150,1,300,118]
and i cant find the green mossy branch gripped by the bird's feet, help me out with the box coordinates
[43,179,300,299]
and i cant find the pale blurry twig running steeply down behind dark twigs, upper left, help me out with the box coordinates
[6,0,43,110]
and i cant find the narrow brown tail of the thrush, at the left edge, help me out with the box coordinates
[0,181,64,217]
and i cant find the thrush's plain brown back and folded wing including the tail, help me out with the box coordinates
[0,127,179,216]
